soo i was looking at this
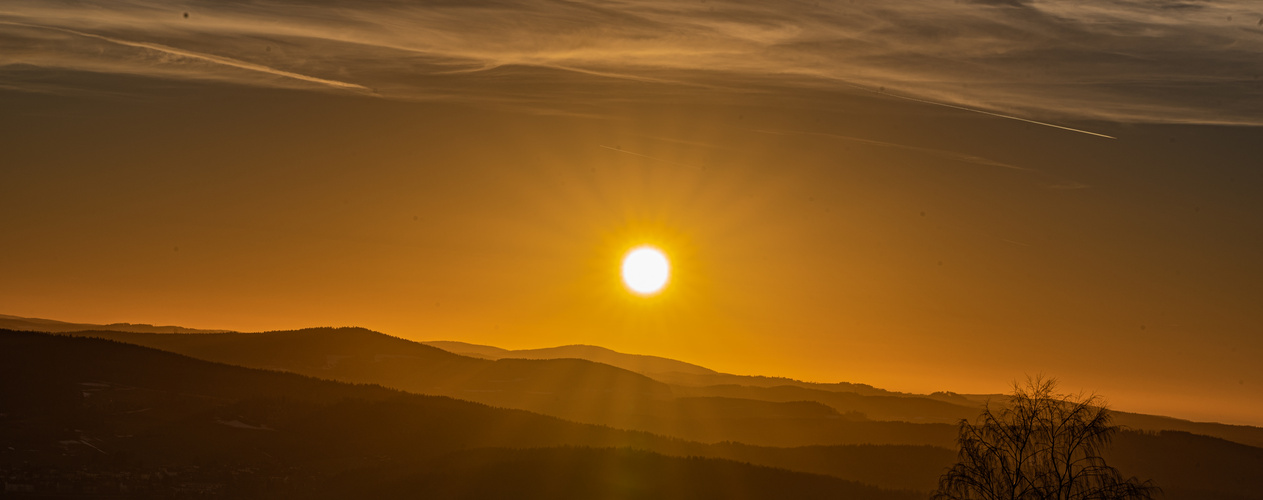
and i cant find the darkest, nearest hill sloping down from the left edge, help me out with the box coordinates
[0,331,919,499]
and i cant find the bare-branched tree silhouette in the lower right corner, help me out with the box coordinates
[932,378,1161,500]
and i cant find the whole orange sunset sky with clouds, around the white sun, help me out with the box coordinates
[0,0,1263,424]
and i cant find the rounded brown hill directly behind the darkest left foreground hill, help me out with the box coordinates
[73,328,671,398]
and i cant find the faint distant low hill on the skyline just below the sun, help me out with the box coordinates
[422,341,716,376]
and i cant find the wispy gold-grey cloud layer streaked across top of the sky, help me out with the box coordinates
[0,0,1263,124]
